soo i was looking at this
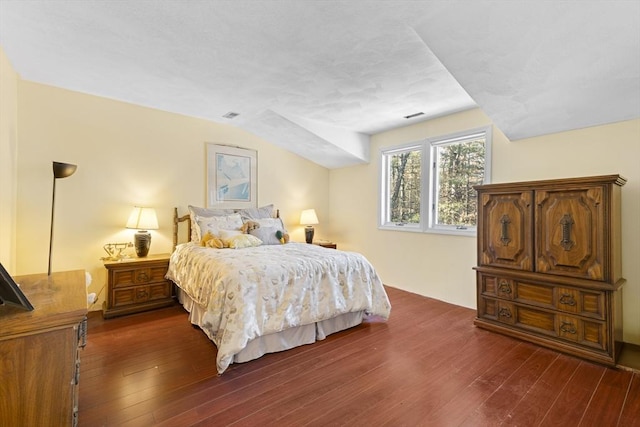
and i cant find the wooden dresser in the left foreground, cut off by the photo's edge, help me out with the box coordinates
[0,270,87,426]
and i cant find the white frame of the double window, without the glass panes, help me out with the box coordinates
[378,126,493,236]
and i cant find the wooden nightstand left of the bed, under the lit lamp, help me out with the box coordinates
[102,254,174,319]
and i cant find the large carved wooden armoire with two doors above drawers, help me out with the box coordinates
[475,175,626,365]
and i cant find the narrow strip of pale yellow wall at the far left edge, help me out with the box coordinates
[0,48,18,274]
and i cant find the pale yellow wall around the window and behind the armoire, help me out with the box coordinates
[330,110,640,344]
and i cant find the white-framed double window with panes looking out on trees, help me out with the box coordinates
[380,127,491,235]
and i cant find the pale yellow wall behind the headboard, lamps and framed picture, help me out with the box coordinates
[15,80,329,309]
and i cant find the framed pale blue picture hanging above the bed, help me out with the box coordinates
[206,143,258,209]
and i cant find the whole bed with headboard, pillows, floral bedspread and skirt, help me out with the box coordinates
[166,205,391,374]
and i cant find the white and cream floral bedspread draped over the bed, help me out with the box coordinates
[166,243,391,373]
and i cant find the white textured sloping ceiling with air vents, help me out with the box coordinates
[0,0,640,168]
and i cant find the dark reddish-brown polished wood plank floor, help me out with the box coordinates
[79,288,640,427]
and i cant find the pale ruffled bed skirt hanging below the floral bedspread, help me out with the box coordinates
[176,287,366,363]
